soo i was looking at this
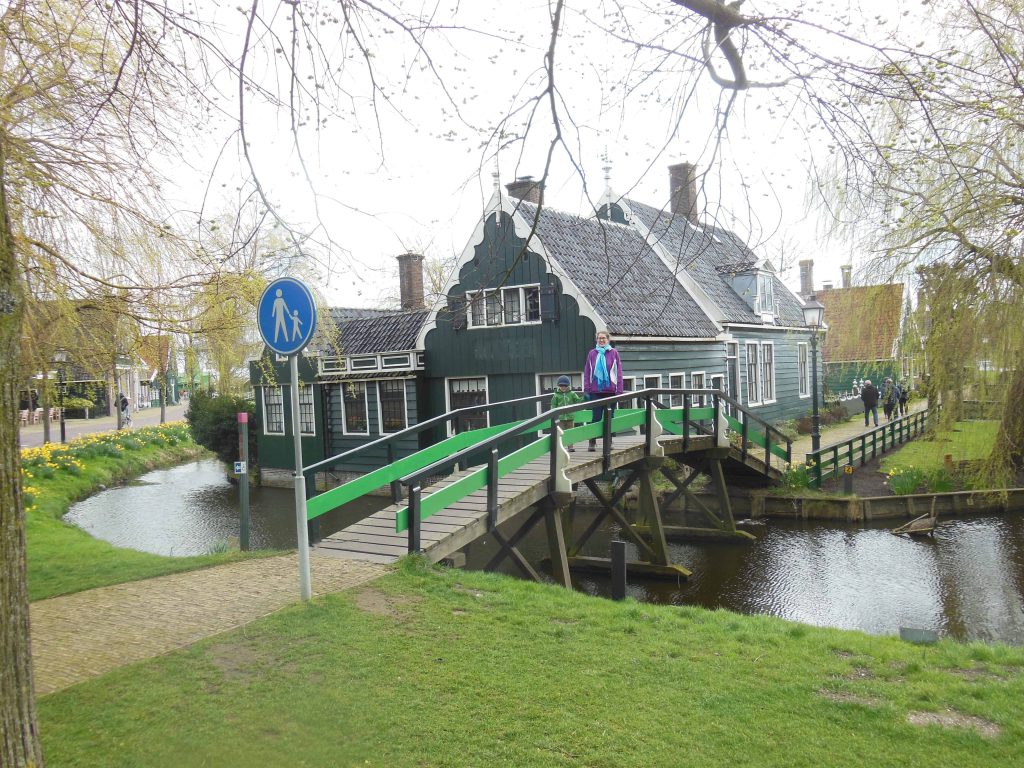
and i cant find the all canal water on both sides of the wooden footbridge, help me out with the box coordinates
[66,461,1024,645]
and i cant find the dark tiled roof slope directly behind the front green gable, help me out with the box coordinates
[518,202,718,338]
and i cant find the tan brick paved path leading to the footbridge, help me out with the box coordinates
[31,554,388,696]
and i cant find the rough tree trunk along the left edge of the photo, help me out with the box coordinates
[0,131,43,768]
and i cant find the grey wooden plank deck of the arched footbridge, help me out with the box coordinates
[314,434,714,563]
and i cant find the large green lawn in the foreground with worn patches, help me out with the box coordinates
[40,566,1024,768]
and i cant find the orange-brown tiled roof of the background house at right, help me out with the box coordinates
[816,283,903,362]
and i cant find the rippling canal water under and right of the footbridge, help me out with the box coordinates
[469,512,1024,645]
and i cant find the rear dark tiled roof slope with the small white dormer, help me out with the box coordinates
[626,200,804,326]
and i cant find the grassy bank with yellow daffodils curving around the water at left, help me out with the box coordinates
[22,423,276,600]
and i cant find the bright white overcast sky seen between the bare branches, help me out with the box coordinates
[163,0,925,306]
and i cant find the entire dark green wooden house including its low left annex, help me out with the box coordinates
[252,166,823,483]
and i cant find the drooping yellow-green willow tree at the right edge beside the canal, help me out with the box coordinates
[822,0,1024,482]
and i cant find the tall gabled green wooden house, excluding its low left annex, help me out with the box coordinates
[421,164,811,434]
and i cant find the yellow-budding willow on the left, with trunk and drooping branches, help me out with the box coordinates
[0,0,468,767]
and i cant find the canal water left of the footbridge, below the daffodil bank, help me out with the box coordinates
[65,460,384,556]
